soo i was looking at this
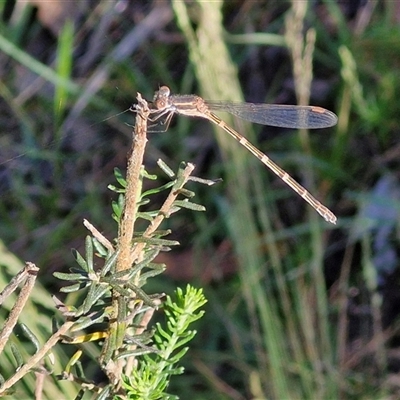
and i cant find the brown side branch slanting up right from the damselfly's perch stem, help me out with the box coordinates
[131,163,194,260]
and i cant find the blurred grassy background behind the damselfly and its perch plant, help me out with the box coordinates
[0,0,400,399]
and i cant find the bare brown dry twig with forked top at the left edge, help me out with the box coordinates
[0,263,39,354]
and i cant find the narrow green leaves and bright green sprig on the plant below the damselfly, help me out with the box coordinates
[50,163,206,399]
